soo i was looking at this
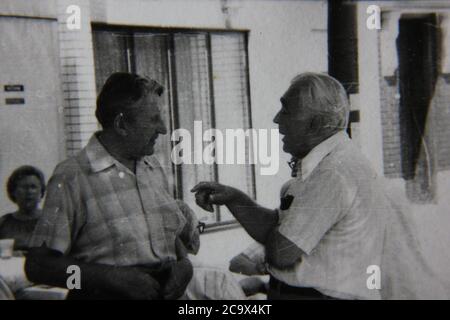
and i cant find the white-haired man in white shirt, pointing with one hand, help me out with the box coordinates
[192,73,391,299]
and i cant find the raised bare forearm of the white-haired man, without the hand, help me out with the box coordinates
[227,192,278,244]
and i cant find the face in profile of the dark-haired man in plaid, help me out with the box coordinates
[126,94,167,159]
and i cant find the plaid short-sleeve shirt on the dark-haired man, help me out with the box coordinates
[30,135,198,267]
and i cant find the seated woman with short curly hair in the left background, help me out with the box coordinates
[0,166,45,250]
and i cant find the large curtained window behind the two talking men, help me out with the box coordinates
[93,25,256,230]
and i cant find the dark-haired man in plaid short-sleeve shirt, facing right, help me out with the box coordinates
[25,73,199,299]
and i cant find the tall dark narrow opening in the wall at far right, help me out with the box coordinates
[397,14,438,201]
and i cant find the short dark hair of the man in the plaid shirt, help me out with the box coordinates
[95,72,164,128]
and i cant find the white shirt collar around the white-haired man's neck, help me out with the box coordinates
[298,131,349,181]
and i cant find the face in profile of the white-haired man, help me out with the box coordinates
[273,87,313,158]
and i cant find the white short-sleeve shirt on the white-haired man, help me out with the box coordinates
[268,131,391,299]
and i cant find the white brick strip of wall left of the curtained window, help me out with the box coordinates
[57,0,98,155]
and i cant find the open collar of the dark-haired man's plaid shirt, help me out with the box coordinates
[85,132,155,172]
